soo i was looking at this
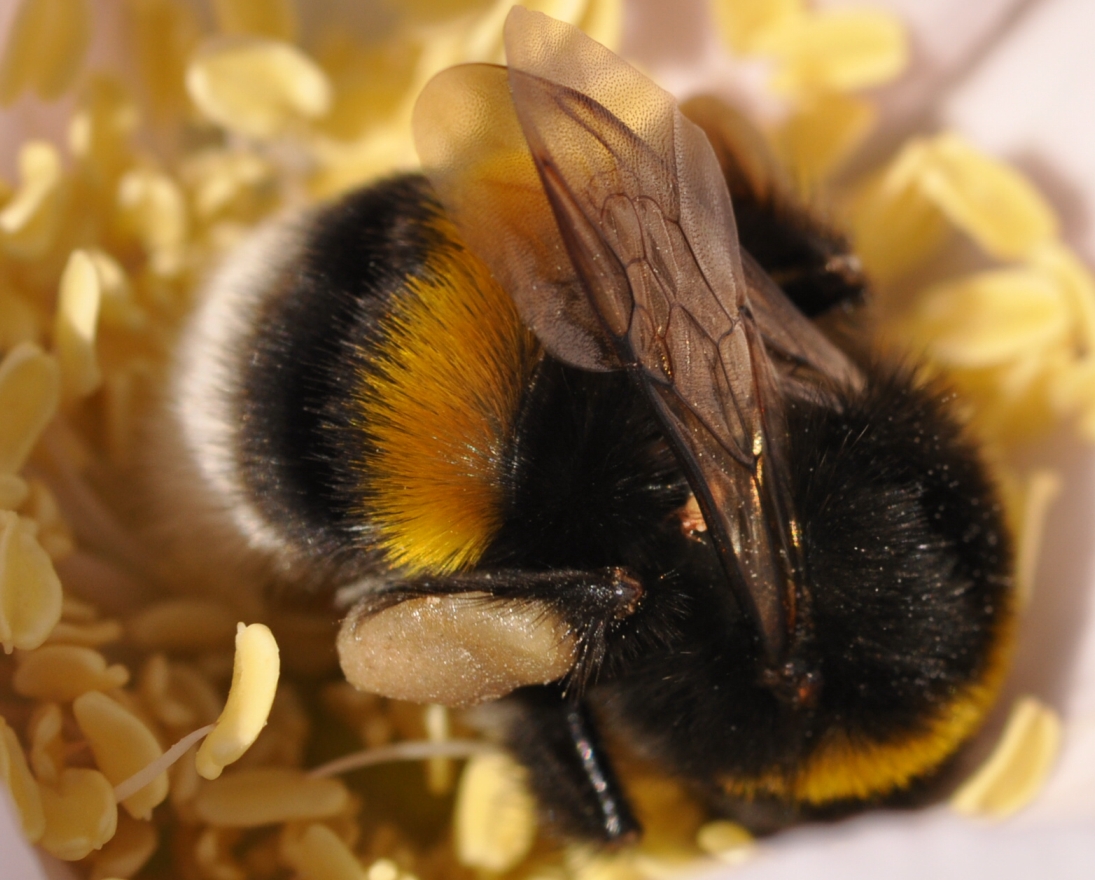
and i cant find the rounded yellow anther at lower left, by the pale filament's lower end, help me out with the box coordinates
[38,767,118,861]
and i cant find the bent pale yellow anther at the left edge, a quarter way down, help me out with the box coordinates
[0,140,64,260]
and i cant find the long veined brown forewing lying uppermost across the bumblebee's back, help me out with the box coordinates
[506,10,797,662]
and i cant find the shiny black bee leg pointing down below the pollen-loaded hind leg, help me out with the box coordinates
[505,687,642,845]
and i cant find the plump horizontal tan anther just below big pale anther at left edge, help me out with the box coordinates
[12,645,129,703]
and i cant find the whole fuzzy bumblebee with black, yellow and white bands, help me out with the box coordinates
[158,8,1013,844]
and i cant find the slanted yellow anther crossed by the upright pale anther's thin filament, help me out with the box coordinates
[72,691,168,819]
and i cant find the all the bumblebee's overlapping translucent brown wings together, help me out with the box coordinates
[415,8,858,663]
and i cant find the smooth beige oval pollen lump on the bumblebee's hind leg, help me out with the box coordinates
[337,593,578,708]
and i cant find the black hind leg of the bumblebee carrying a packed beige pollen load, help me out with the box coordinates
[336,568,643,706]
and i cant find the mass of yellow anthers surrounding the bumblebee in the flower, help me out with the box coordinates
[0,0,1081,880]
